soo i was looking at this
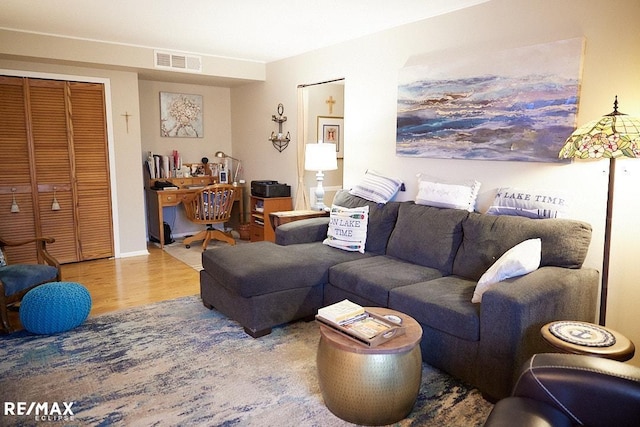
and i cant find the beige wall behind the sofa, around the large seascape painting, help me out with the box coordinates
[231,0,640,364]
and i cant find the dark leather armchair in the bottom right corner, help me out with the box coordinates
[485,353,640,427]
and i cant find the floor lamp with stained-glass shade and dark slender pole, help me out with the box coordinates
[559,96,640,326]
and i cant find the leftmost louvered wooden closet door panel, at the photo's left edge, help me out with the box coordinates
[0,76,36,262]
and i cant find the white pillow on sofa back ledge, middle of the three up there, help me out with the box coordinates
[415,174,480,212]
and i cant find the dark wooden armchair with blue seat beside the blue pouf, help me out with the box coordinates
[0,237,61,332]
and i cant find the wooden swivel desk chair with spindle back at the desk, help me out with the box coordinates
[183,184,236,250]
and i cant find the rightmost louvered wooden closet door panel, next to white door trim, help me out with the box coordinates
[69,82,113,260]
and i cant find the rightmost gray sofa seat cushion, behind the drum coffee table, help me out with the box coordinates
[389,276,480,341]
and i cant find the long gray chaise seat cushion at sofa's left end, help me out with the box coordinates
[202,242,368,298]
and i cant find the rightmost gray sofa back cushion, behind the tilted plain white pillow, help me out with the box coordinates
[453,213,591,280]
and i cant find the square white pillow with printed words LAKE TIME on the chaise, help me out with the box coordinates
[322,205,369,253]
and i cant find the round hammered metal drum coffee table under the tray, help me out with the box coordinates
[317,307,422,425]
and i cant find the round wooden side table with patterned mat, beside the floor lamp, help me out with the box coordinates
[540,320,636,362]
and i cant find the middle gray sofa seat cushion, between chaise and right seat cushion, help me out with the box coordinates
[329,255,442,307]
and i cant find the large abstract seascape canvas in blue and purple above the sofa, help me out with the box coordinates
[396,38,584,162]
